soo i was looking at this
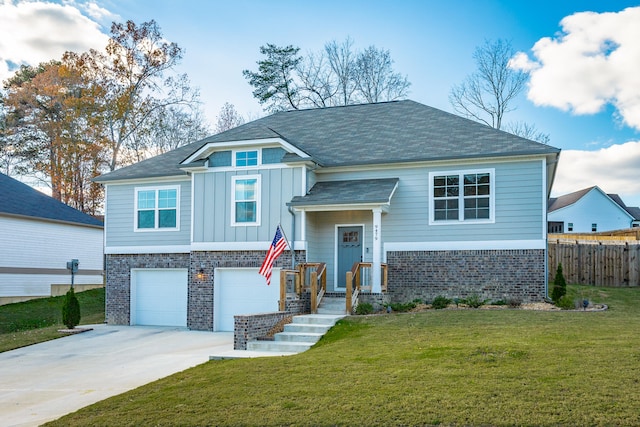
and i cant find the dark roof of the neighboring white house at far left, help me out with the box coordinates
[0,173,102,227]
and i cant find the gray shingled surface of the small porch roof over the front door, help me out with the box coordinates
[289,178,399,206]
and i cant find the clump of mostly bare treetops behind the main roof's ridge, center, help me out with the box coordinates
[243,38,410,111]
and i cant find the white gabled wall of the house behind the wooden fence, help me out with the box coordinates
[548,188,631,233]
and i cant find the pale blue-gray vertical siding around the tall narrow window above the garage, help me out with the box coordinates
[193,167,304,243]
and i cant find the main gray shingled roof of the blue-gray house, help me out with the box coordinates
[97,101,560,182]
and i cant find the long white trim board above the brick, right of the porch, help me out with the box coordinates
[384,239,547,252]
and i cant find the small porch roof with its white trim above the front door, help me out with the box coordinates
[288,178,399,212]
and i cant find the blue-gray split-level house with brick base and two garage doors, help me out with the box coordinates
[98,101,560,331]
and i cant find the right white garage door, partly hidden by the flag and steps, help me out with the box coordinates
[213,268,280,331]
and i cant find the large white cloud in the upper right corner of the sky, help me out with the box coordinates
[511,7,640,129]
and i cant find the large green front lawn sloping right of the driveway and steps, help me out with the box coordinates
[46,286,640,426]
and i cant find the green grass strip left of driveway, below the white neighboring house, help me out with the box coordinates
[0,288,104,352]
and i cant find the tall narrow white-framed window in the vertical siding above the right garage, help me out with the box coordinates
[231,175,260,225]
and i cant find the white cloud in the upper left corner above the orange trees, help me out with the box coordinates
[0,0,108,82]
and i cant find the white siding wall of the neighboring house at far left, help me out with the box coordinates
[0,216,103,297]
